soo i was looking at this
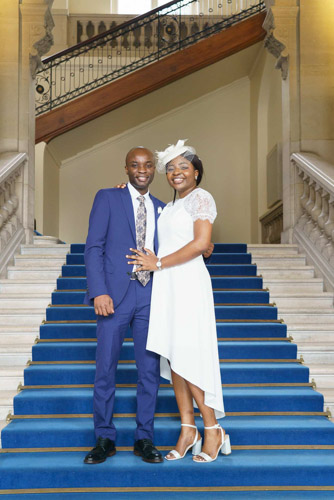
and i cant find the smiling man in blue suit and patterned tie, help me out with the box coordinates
[84,147,165,464]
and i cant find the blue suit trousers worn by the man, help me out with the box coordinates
[94,280,160,441]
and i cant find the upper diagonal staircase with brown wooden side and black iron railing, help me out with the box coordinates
[36,0,266,144]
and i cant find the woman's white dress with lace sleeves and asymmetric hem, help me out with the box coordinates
[147,188,225,418]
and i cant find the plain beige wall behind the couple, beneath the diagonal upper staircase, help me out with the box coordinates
[59,78,250,243]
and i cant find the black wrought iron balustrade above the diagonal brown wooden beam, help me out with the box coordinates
[36,0,265,115]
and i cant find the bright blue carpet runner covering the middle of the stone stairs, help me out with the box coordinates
[0,244,334,494]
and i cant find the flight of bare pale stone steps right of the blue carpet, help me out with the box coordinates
[248,245,334,415]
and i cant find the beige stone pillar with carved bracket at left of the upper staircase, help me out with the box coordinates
[18,0,54,243]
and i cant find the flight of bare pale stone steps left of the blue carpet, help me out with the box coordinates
[0,236,70,442]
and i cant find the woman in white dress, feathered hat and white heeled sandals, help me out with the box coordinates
[127,141,231,463]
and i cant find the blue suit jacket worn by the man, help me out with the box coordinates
[84,187,165,307]
